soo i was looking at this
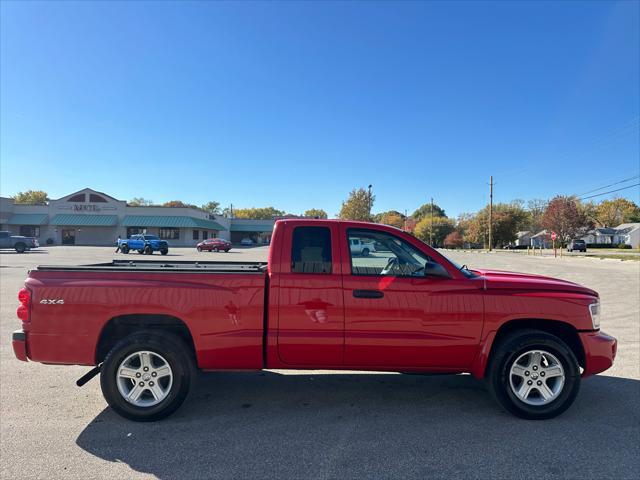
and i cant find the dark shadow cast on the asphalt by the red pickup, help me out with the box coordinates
[76,372,640,479]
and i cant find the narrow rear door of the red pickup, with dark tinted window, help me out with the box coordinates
[278,222,344,368]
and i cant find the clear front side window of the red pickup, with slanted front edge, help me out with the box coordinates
[347,229,442,277]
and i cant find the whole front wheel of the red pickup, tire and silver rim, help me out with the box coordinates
[487,329,580,420]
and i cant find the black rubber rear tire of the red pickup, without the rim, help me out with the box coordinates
[100,331,196,422]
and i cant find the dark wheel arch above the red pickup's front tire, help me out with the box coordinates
[472,318,586,378]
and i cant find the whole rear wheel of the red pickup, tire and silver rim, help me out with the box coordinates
[100,331,195,422]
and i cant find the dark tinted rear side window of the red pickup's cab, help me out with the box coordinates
[291,227,331,273]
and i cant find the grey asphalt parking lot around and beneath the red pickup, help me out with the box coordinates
[0,247,640,479]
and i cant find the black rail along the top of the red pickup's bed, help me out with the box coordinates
[37,260,267,274]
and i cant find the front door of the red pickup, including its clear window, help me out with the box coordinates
[342,229,483,370]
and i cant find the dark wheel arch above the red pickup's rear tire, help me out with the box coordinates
[95,313,197,364]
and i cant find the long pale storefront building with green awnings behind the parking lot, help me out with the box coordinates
[0,188,275,246]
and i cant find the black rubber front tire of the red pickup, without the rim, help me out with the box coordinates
[486,329,580,420]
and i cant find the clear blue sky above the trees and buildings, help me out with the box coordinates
[0,1,640,215]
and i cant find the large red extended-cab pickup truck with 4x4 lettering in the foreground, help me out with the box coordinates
[13,219,616,421]
